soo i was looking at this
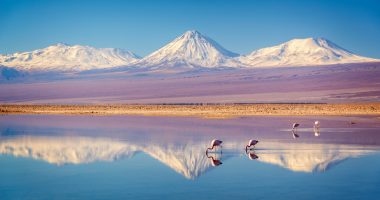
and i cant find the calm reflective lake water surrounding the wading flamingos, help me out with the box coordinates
[0,115,380,200]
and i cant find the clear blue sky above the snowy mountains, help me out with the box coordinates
[0,0,380,58]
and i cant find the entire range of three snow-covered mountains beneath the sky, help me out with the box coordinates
[0,30,380,74]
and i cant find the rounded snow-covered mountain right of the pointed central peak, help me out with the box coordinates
[238,38,380,67]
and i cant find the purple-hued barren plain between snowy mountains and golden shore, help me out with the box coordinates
[0,63,380,104]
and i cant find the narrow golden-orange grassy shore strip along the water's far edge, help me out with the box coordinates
[0,102,380,118]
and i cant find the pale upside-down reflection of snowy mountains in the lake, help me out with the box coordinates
[0,136,377,179]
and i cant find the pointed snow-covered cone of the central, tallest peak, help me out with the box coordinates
[136,31,240,68]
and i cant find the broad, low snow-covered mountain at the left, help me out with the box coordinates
[0,43,139,71]
